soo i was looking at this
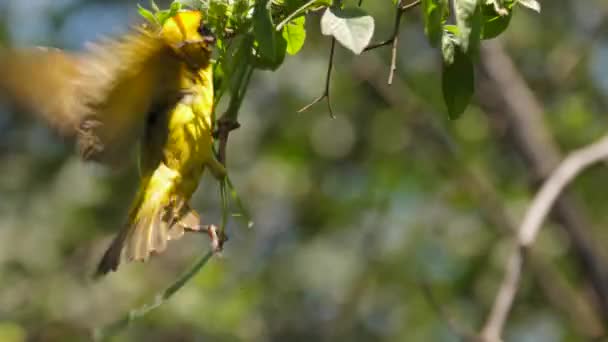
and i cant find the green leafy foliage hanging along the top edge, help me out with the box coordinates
[133,0,540,119]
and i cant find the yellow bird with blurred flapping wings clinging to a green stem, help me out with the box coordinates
[0,11,225,274]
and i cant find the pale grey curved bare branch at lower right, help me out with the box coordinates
[481,135,608,342]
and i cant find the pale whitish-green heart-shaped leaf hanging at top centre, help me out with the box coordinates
[321,7,374,55]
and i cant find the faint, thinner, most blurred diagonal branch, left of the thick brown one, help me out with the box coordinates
[353,51,604,339]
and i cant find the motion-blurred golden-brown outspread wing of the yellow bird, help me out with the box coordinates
[0,30,180,164]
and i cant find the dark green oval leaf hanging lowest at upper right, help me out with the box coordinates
[441,46,475,120]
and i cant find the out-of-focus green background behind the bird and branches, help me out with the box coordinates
[0,0,608,342]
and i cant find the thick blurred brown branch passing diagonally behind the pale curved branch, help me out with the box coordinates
[476,41,608,327]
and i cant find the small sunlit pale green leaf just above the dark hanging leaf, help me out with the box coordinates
[454,0,481,52]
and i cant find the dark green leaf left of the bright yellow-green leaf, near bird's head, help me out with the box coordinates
[253,0,287,70]
